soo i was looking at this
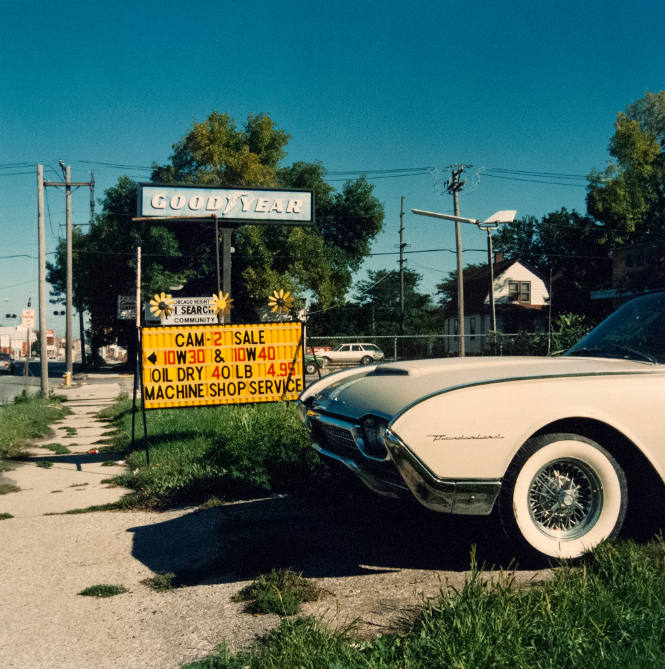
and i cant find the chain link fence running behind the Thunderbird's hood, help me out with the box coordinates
[307,332,555,360]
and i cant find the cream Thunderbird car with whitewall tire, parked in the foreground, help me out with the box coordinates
[298,292,665,558]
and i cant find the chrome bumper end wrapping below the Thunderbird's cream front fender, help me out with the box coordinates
[386,430,501,516]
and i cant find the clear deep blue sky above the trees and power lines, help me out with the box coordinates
[0,0,665,332]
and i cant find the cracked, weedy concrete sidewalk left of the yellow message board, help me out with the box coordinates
[0,377,130,518]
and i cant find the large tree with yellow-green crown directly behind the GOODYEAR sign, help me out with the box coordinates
[147,112,383,319]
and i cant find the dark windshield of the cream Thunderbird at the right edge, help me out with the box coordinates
[564,292,665,363]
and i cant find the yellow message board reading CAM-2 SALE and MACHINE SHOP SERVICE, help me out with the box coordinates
[141,322,304,409]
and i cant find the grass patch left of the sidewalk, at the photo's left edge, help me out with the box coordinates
[0,393,71,458]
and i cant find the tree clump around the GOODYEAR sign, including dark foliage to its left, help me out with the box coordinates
[49,112,383,360]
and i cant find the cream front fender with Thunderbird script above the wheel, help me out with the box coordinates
[390,373,665,479]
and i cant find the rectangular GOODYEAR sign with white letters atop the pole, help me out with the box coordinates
[138,184,314,225]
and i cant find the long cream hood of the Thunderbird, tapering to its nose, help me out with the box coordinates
[300,356,652,419]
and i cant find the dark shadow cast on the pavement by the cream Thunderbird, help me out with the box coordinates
[129,482,543,584]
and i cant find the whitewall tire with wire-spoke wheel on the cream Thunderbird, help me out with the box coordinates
[499,433,628,559]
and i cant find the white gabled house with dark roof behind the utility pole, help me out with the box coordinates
[444,254,550,354]
